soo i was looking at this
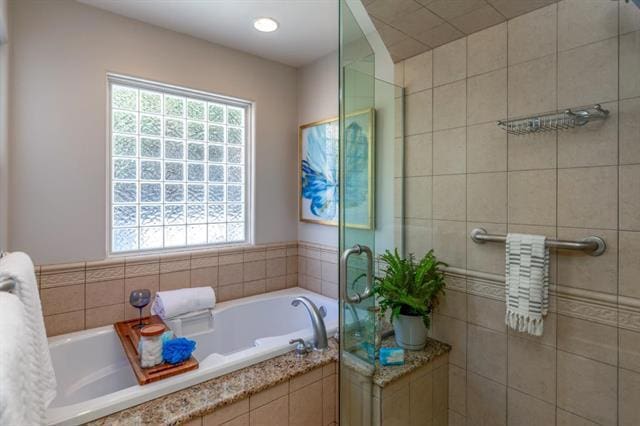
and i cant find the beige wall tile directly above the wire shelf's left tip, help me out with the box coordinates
[467,68,507,124]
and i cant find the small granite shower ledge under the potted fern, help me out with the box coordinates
[373,336,451,388]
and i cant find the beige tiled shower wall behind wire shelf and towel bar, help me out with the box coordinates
[398,0,640,425]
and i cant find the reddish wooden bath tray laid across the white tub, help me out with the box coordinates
[113,315,198,385]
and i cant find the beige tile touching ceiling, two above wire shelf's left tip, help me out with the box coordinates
[467,23,507,76]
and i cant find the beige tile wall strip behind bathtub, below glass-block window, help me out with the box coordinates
[36,242,298,336]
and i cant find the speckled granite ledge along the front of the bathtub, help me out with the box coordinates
[88,338,338,426]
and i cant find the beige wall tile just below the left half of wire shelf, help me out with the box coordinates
[508,131,558,170]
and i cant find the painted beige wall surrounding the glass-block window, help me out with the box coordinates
[9,0,297,263]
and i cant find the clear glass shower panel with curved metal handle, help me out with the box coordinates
[339,0,403,426]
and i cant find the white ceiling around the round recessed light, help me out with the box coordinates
[78,0,338,67]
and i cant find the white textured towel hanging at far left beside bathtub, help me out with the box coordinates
[0,252,56,425]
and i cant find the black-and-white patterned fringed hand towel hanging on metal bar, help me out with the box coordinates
[505,234,549,336]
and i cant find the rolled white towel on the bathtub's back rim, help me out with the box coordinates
[151,287,216,319]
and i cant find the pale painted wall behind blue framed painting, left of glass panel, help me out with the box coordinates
[296,52,338,247]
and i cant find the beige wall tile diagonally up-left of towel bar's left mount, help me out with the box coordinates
[433,175,467,221]
